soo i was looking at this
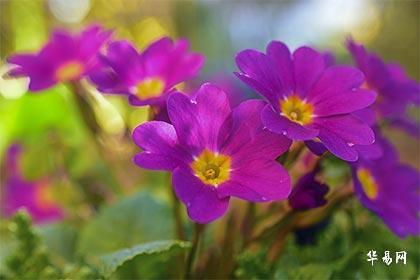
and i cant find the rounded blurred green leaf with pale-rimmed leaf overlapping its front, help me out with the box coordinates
[78,193,189,279]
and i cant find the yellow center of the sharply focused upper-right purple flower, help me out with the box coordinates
[280,95,314,125]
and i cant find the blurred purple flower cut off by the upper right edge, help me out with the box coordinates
[347,39,420,137]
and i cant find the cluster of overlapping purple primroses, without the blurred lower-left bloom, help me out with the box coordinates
[4,26,420,237]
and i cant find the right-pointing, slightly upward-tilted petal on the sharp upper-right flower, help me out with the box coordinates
[313,89,376,117]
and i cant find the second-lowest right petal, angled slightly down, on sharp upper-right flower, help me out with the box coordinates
[316,115,375,145]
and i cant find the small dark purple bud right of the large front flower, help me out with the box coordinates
[288,171,328,210]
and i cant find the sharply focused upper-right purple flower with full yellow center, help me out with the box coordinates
[236,41,376,161]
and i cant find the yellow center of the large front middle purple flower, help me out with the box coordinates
[191,149,231,187]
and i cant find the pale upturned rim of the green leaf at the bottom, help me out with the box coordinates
[99,240,190,277]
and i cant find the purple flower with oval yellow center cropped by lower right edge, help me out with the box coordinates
[352,137,420,238]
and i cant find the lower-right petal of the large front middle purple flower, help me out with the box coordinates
[217,160,291,202]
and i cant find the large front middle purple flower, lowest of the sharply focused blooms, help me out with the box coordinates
[133,84,291,223]
